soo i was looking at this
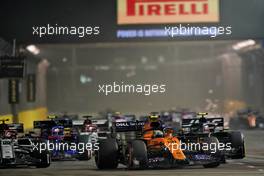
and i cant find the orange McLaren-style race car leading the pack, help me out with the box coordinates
[95,113,238,169]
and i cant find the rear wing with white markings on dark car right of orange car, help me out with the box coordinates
[182,117,224,130]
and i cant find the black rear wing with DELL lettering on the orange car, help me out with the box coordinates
[113,121,145,132]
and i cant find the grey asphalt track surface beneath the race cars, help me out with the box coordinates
[0,131,264,176]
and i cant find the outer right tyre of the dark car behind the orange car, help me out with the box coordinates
[230,131,245,159]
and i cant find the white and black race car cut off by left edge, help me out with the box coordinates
[0,121,50,168]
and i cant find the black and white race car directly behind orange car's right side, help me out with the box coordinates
[182,113,245,164]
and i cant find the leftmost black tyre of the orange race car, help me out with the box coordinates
[95,138,118,169]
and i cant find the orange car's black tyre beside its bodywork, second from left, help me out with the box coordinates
[128,140,148,169]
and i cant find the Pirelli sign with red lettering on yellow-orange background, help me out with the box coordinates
[117,0,219,24]
